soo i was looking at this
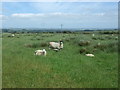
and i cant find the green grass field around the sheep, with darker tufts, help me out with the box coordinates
[2,32,118,88]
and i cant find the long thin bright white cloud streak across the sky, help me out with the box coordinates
[11,12,111,18]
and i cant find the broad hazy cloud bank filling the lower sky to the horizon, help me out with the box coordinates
[0,12,117,28]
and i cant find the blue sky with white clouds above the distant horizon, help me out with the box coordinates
[0,2,118,29]
